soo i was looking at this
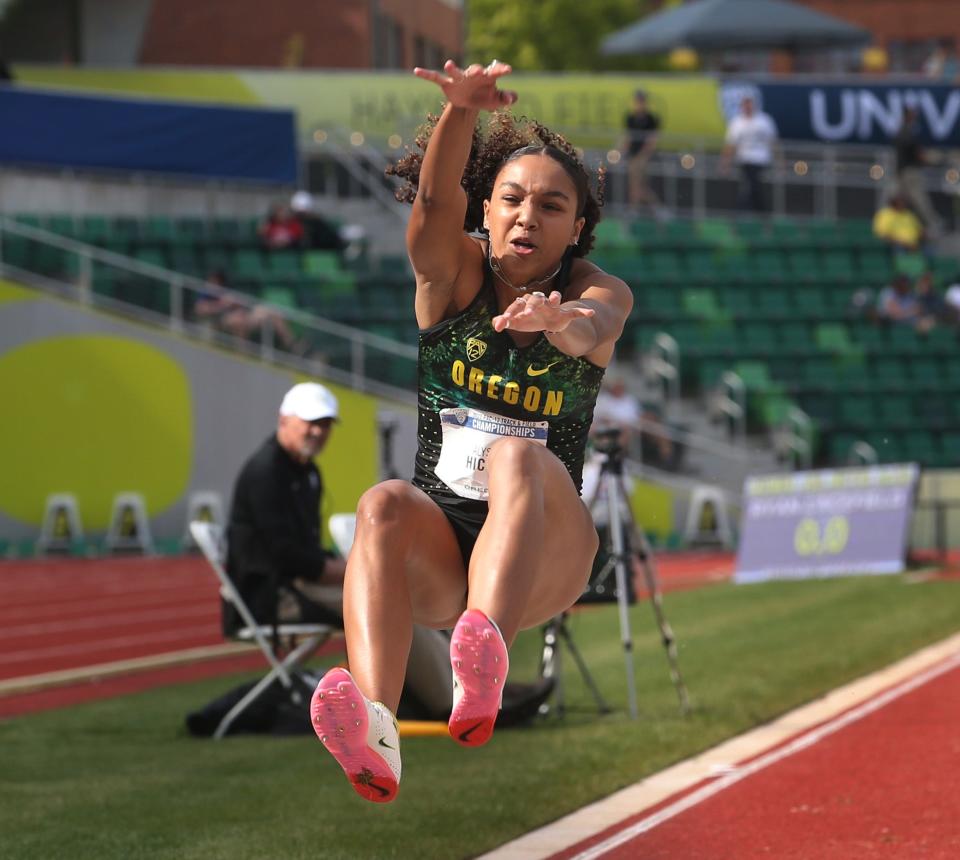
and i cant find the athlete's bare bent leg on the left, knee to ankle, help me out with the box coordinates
[343,481,467,713]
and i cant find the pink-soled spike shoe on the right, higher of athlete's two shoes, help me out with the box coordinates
[448,609,510,747]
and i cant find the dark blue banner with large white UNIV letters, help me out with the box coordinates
[721,81,960,147]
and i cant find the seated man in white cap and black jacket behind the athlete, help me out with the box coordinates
[224,382,453,717]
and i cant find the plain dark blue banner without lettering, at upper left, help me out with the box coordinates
[0,86,297,184]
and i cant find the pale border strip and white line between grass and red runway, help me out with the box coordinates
[478,634,960,860]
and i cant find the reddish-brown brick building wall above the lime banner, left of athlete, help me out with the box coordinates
[140,0,463,69]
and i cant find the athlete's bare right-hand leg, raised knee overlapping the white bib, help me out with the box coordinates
[467,439,598,645]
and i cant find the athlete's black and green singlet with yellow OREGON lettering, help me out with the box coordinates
[413,255,604,509]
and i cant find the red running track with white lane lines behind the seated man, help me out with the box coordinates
[0,553,733,718]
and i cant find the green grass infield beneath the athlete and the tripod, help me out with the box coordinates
[0,577,960,860]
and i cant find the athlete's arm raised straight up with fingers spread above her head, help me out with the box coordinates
[407,60,516,318]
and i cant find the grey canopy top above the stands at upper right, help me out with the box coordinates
[600,0,871,56]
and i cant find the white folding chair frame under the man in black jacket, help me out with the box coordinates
[190,520,337,739]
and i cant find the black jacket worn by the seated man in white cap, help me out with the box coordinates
[224,436,328,631]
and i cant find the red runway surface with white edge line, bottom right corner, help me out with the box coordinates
[553,655,960,860]
